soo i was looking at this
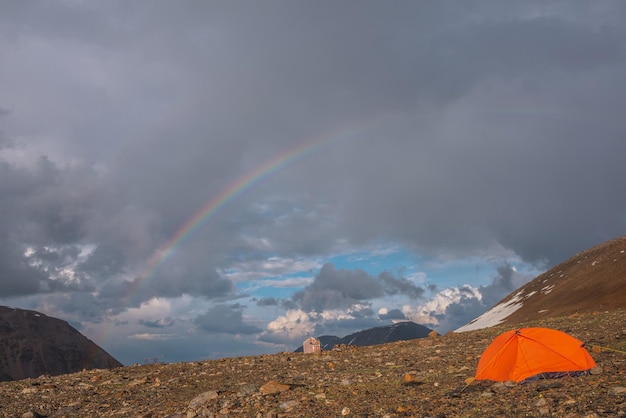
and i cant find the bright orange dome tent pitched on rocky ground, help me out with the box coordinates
[476,328,596,382]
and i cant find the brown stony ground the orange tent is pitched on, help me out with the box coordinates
[0,310,626,418]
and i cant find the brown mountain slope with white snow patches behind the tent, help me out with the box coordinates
[456,236,626,332]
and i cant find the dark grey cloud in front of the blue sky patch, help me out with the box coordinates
[292,263,424,312]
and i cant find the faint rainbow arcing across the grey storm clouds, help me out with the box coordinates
[125,118,388,303]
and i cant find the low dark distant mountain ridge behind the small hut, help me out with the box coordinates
[295,321,432,352]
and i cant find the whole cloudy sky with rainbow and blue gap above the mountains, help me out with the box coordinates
[0,0,626,364]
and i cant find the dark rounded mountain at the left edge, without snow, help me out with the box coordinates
[0,306,122,381]
